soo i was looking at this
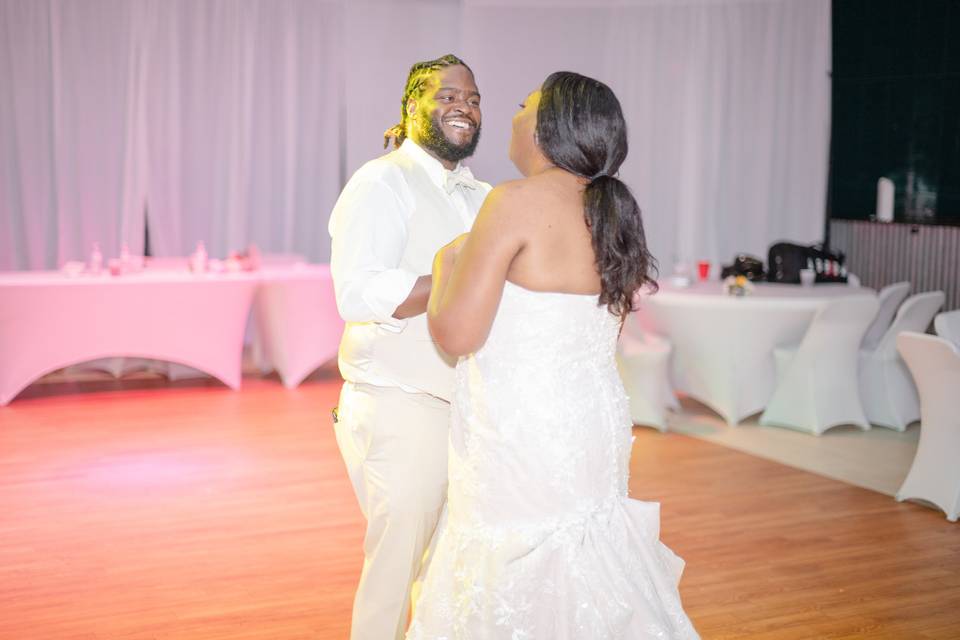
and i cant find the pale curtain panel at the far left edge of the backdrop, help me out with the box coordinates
[0,0,143,269]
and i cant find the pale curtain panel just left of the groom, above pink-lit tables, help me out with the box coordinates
[144,0,344,260]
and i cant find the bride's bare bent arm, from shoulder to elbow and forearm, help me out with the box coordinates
[427,183,524,356]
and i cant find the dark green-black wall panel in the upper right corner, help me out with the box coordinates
[830,0,960,224]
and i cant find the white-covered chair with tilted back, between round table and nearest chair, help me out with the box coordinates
[860,291,945,431]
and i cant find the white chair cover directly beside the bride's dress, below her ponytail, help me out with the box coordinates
[617,314,678,431]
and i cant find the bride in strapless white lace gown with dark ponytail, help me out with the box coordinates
[407,72,697,640]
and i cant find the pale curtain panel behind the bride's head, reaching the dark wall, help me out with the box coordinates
[463,0,831,274]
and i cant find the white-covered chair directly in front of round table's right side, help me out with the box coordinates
[760,297,879,435]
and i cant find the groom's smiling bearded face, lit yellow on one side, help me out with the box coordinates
[407,65,481,163]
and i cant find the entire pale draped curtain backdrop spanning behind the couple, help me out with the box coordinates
[0,0,830,273]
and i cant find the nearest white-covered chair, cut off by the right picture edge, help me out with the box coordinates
[897,332,960,522]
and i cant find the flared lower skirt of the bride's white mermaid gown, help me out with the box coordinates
[407,497,698,640]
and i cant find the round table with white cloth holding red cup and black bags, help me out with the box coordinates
[635,281,876,425]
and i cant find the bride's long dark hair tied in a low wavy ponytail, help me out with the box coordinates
[536,71,657,319]
